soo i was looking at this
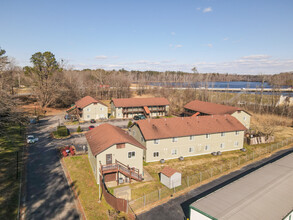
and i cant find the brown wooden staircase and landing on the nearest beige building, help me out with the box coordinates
[100,160,143,182]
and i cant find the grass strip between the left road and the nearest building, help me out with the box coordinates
[64,155,113,220]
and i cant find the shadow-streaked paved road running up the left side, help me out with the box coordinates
[25,116,80,220]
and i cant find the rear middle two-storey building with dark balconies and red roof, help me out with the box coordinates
[111,98,169,118]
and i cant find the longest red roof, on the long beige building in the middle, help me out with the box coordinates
[133,115,246,140]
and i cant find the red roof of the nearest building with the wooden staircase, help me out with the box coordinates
[85,123,145,156]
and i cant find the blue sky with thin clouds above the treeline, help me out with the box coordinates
[0,0,293,74]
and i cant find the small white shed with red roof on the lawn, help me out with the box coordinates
[160,167,181,189]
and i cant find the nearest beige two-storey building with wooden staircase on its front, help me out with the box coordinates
[86,124,145,184]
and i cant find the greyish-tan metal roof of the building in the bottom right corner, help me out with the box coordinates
[190,154,293,220]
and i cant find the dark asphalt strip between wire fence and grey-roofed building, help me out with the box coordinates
[138,148,293,220]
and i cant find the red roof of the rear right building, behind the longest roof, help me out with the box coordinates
[184,100,248,115]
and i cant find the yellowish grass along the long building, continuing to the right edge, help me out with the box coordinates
[110,114,293,200]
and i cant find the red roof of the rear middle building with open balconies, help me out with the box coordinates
[112,98,170,107]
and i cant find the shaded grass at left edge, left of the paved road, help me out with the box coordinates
[0,127,25,219]
